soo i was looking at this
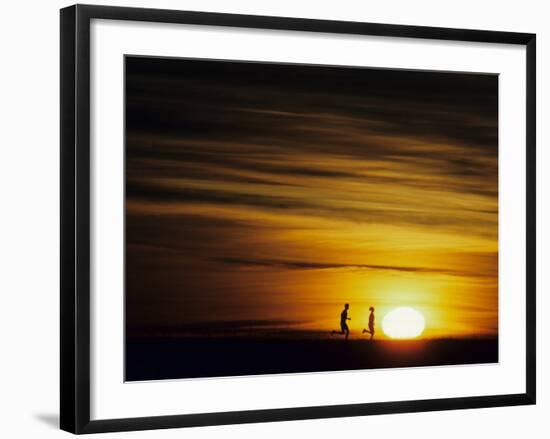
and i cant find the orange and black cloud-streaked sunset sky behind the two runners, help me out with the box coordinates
[126,57,498,337]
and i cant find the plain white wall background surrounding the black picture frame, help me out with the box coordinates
[0,0,550,439]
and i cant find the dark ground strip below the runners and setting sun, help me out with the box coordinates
[126,337,498,381]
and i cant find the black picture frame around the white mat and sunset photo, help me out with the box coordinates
[60,5,536,434]
